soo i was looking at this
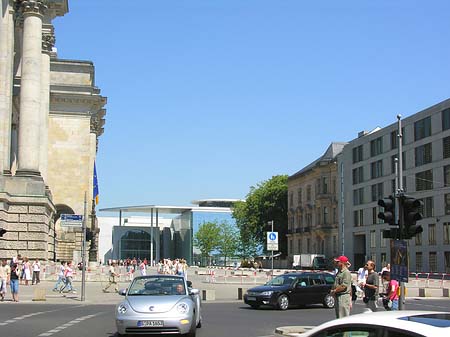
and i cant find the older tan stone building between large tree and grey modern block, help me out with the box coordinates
[287,143,345,264]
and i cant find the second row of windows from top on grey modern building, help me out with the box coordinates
[352,137,450,185]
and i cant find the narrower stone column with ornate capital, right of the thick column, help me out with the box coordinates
[39,28,55,183]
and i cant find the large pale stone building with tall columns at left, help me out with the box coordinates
[0,0,106,260]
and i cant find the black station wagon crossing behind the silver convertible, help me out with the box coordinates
[244,272,334,310]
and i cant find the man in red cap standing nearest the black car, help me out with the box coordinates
[330,255,352,318]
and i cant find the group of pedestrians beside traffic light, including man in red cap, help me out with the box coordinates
[331,256,399,318]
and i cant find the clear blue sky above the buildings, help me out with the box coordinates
[54,0,450,208]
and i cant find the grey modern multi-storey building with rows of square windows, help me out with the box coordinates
[338,99,450,273]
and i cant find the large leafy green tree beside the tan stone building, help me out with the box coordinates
[233,175,288,257]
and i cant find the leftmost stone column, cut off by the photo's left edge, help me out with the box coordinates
[0,0,14,174]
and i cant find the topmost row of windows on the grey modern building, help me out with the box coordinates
[353,108,450,163]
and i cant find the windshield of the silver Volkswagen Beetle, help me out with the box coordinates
[128,276,186,296]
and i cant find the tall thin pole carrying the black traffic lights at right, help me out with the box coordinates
[391,115,405,310]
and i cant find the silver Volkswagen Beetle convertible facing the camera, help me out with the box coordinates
[116,275,202,337]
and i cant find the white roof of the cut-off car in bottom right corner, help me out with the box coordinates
[300,310,450,337]
